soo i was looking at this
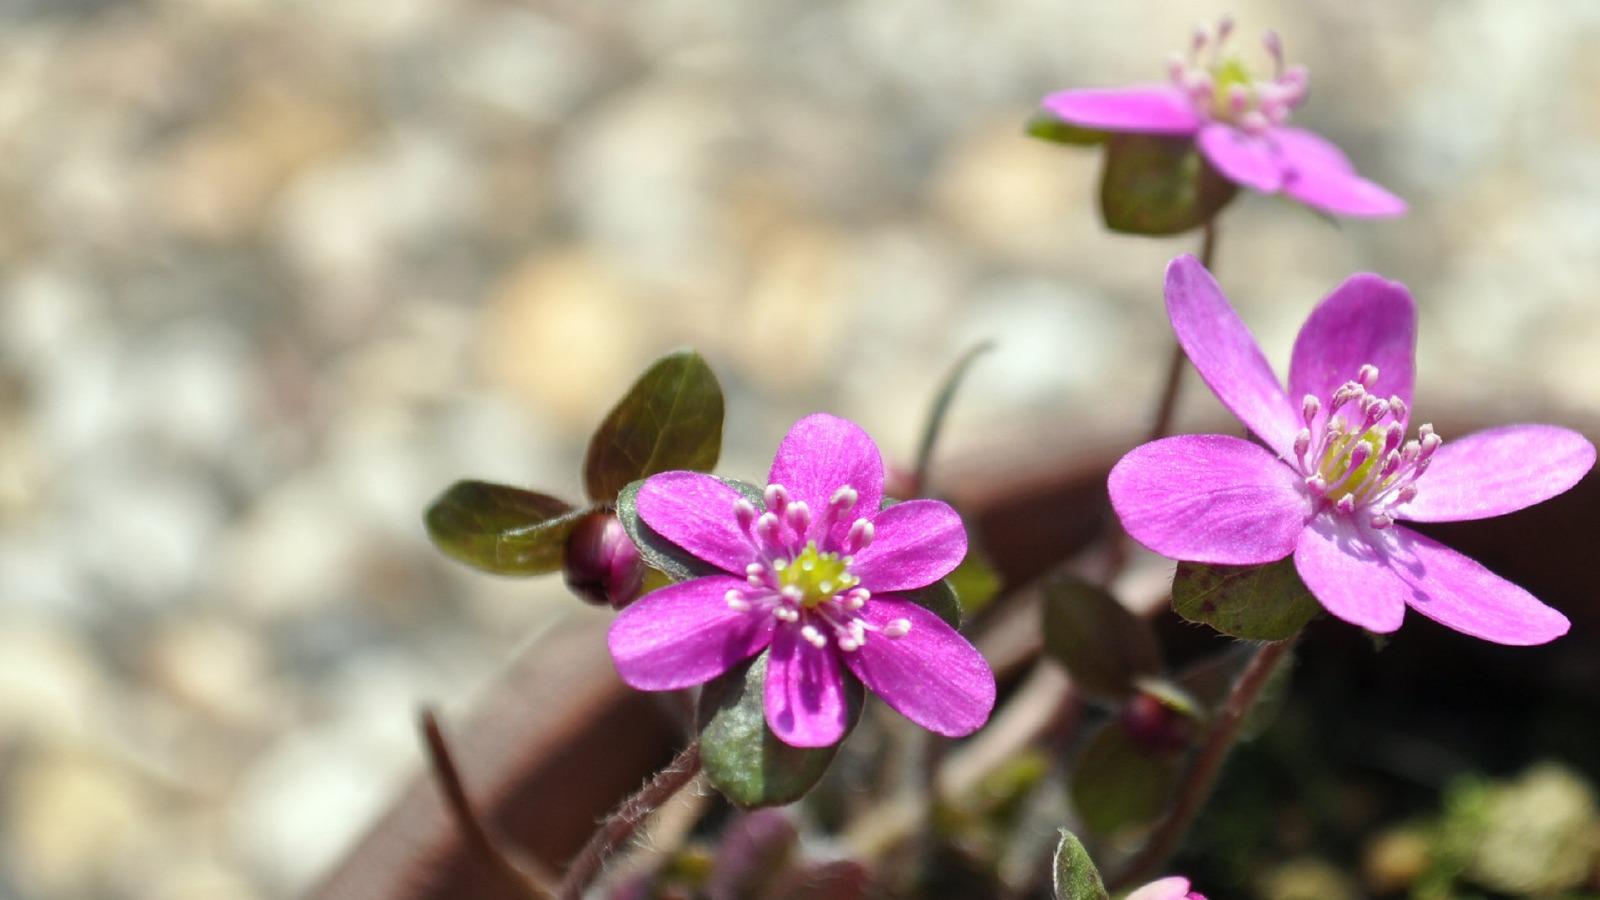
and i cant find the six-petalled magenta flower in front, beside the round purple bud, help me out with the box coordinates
[610,415,995,746]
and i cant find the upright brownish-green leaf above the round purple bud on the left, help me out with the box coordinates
[584,351,722,503]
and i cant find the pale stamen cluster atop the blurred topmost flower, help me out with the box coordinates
[1168,18,1309,133]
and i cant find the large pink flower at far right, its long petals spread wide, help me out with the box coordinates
[1109,256,1595,644]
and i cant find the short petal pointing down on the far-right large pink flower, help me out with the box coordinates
[1294,516,1410,634]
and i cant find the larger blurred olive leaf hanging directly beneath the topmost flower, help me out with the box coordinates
[1101,135,1238,235]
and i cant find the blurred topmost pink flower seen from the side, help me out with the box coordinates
[1043,19,1406,216]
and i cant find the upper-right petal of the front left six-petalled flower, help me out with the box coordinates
[850,500,966,593]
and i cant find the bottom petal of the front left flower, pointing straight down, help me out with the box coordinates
[763,625,850,746]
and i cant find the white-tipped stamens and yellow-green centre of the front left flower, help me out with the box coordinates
[726,484,910,652]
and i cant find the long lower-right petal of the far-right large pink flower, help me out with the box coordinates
[1386,525,1571,647]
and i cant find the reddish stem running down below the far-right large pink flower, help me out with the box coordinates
[1112,637,1294,887]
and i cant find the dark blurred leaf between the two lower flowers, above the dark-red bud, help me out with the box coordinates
[1043,577,1162,701]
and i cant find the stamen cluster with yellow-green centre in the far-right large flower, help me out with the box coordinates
[1294,365,1443,528]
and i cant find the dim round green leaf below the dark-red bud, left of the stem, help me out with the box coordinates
[1070,721,1184,836]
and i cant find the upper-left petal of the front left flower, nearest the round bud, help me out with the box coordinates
[637,472,757,573]
